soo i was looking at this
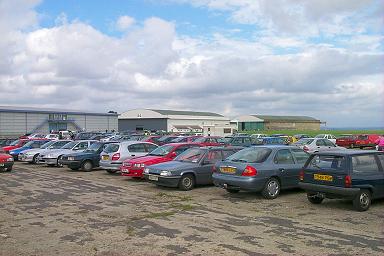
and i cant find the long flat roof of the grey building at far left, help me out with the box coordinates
[0,106,118,116]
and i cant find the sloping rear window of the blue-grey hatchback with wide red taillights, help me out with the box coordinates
[226,147,272,163]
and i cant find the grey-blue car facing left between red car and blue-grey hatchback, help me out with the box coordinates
[144,147,238,190]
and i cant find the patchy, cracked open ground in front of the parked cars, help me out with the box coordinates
[0,163,384,255]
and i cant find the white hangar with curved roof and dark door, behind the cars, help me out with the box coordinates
[119,109,233,136]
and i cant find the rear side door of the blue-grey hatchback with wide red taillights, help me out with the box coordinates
[273,149,299,188]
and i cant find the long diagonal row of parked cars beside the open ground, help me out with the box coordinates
[0,132,384,211]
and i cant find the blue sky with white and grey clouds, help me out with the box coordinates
[0,0,384,127]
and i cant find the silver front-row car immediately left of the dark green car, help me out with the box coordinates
[37,140,96,167]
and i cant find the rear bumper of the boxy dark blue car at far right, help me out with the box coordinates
[299,182,360,198]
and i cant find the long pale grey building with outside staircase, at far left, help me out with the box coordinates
[0,106,118,137]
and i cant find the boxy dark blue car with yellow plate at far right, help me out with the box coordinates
[299,150,384,211]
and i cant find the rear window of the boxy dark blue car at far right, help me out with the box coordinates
[305,155,346,172]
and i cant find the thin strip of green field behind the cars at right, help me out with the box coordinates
[241,130,384,137]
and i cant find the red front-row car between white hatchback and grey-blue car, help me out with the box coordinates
[120,143,202,178]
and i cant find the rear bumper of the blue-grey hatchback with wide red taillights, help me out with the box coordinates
[212,173,267,192]
